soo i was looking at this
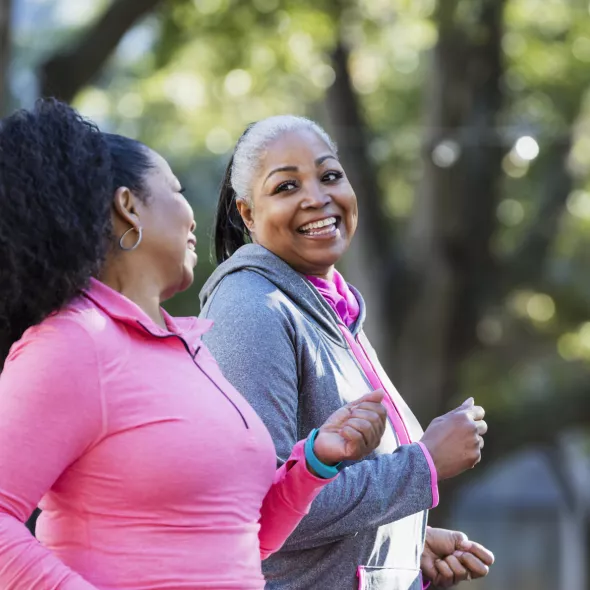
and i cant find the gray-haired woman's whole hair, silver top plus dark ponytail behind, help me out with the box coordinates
[214,115,337,264]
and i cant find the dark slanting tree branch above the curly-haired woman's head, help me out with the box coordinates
[40,0,163,102]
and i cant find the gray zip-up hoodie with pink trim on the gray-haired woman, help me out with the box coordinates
[201,245,436,590]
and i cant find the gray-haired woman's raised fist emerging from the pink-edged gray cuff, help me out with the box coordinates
[421,397,488,479]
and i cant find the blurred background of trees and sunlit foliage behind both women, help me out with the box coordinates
[0,0,590,590]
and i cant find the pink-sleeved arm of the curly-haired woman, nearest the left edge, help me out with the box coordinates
[0,319,103,590]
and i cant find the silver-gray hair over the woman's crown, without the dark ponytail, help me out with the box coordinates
[231,115,337,201]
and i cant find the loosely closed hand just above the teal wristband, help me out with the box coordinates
[313,389,387,465]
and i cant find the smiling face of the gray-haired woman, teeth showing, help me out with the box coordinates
[238,129,358,277]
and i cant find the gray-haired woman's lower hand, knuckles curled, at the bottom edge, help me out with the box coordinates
[420,527,494,588]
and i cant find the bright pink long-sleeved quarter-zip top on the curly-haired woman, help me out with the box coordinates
[0,280,330,590]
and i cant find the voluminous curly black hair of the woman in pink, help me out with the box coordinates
[0,99,152,371]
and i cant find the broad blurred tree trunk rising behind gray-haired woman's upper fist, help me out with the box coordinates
[395,0,504,421]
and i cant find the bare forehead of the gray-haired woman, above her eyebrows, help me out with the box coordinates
[260,129,335,171]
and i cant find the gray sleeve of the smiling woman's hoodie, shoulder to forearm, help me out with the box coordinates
[202,272,433,550]
